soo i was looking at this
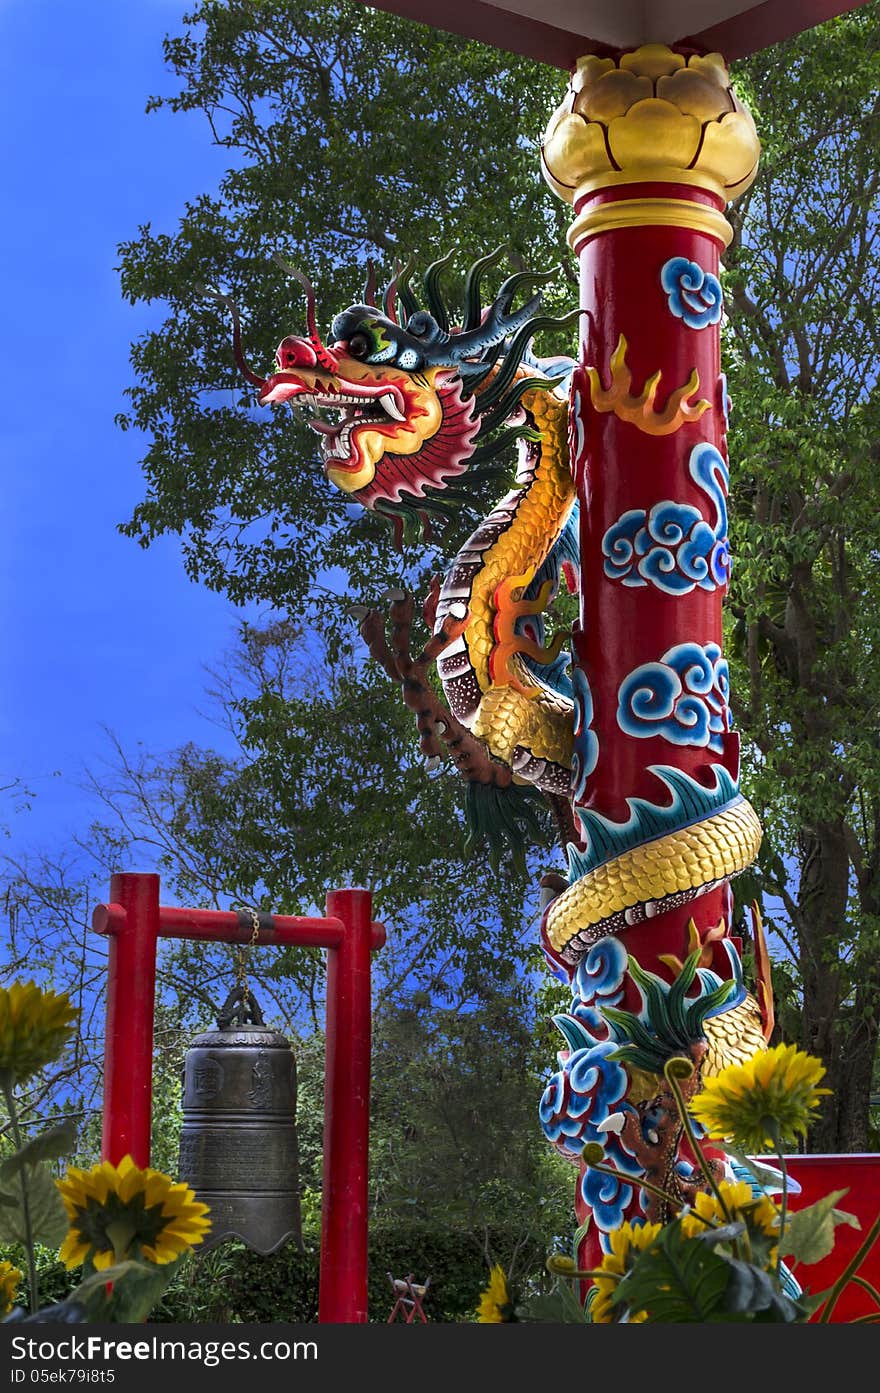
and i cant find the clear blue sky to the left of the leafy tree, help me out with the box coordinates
[0,0,257,853]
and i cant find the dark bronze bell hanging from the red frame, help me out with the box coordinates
[180,986,302,1254]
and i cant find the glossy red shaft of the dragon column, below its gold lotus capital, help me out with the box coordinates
[574,184,739,969]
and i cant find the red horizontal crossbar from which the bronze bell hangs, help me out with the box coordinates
[92,904,386,949]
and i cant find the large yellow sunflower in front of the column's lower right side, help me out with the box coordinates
[689,1045,830,1152]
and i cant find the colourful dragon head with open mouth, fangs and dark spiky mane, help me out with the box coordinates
[217,248,576,528]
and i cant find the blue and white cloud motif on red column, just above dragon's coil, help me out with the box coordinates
[617,644,730,754]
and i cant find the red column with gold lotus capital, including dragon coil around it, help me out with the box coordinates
[543,45,760,1266]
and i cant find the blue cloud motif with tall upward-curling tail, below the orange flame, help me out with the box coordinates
[602,442,731,595]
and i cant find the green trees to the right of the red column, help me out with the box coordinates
[724,3,880,1152]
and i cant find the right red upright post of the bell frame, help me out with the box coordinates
[319,890,372,1325]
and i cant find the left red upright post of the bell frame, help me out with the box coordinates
[102,875,159,1166]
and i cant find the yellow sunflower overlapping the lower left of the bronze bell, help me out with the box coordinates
[56,1156,210,1272]
